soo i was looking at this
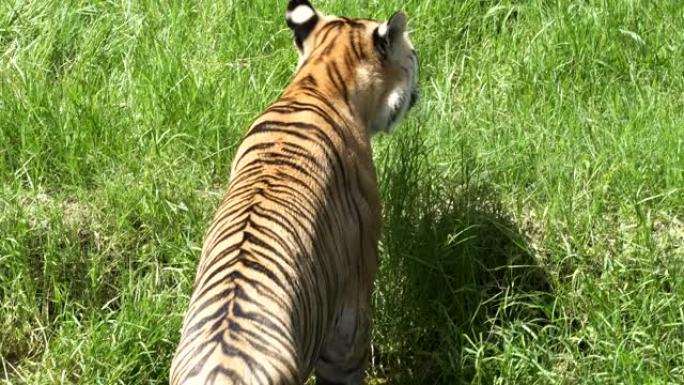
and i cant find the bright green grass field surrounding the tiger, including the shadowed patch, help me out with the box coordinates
[0,0,684,385]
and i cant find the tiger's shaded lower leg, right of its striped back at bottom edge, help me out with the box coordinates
[316,307,370,385]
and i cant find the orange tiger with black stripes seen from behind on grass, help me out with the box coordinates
[170,0,419,385]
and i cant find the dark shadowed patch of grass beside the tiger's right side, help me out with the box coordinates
[374,130,552,384]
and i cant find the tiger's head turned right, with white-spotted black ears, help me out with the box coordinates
[286,0,419,134]
